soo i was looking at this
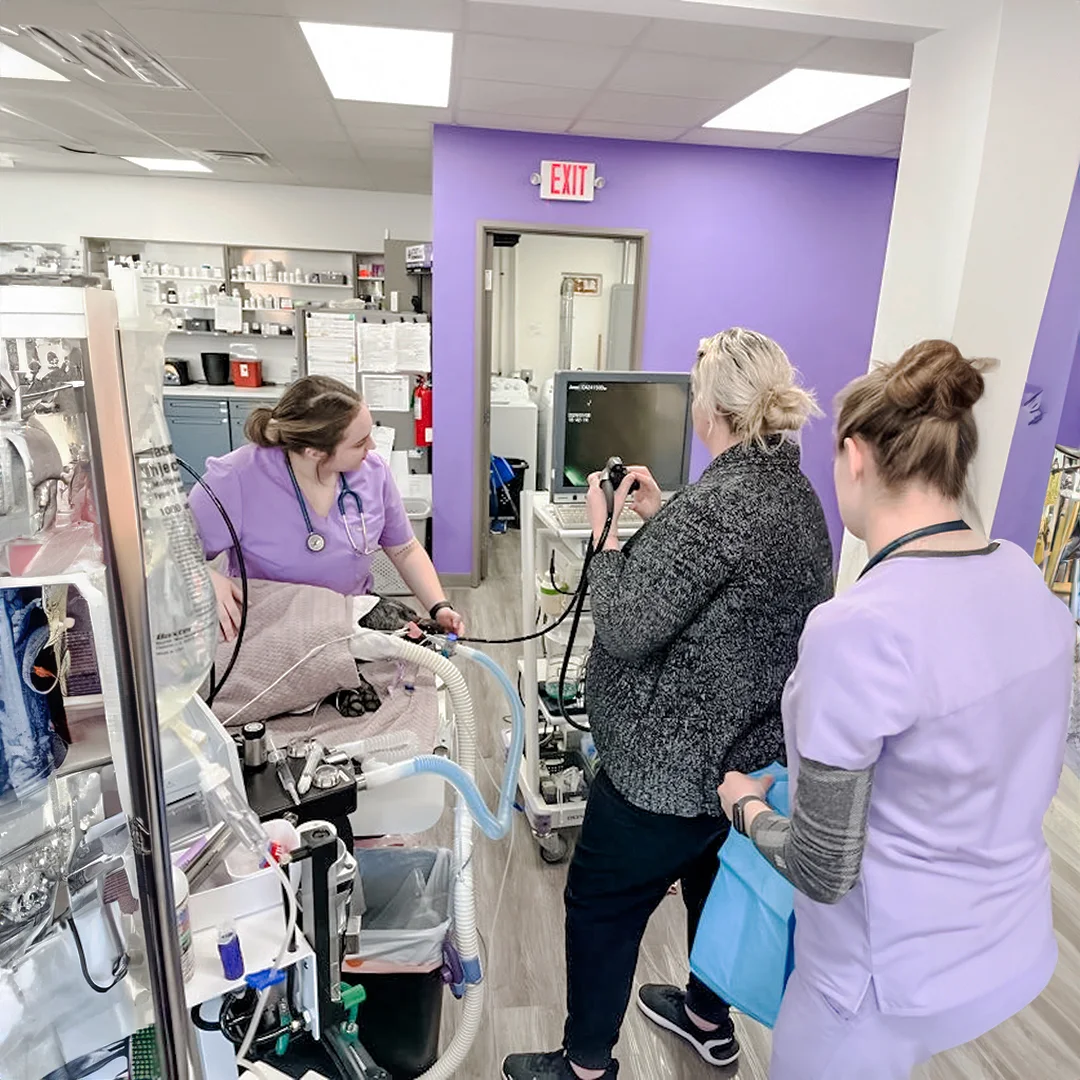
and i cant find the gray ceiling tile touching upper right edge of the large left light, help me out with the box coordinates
[459,33,622,90]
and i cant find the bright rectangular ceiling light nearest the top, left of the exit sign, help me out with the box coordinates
[300,23,454,109]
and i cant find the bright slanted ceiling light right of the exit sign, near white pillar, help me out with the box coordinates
[704,68,912,135]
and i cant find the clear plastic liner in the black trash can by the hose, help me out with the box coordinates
[341,848,454,974]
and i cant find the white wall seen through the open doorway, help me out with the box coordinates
[515,233,622,387]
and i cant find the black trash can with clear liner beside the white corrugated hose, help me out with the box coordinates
[341,848,454,1080]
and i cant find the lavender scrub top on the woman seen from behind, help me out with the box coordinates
[783,543,1076,1023]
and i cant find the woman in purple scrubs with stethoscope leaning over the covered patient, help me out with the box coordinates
[190,375,464,640]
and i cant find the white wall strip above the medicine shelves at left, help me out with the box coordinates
[0,168,431,252]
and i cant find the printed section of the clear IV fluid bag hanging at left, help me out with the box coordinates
[135,446,217,669]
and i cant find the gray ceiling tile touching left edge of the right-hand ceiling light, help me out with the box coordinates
[608,52,784,104]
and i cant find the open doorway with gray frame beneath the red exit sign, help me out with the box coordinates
[473,222,647,584]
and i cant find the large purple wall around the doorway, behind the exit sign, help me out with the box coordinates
[433,127,896,573]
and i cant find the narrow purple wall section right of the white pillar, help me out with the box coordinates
[991,173,1080,551]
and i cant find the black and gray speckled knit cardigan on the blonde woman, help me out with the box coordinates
[585,442,833,818]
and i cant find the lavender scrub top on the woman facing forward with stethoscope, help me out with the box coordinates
[189,444,414,596]
